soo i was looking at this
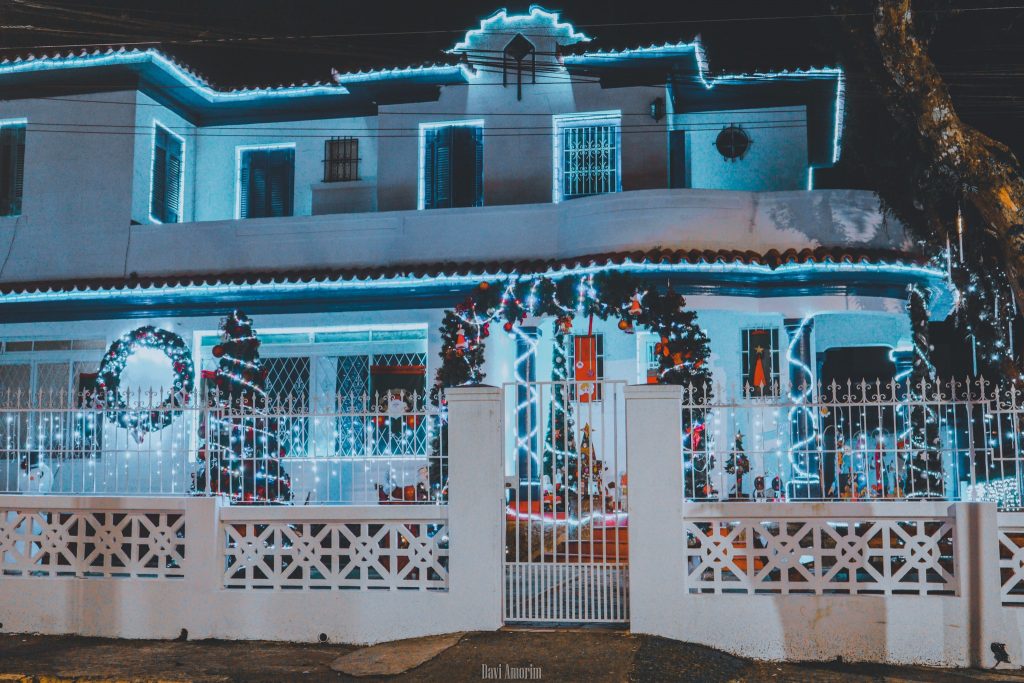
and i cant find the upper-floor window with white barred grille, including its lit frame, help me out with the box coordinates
[553,112,622,202]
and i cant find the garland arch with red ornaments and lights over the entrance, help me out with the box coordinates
[430,271,712,497]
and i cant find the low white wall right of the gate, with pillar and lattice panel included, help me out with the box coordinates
[626,386,1011,667]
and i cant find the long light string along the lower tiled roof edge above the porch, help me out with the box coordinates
[0,259,950,304]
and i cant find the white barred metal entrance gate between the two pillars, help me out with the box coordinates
[503,381,629,624]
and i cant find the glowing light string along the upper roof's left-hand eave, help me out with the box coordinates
[0,48,349,102]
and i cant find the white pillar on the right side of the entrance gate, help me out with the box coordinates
[626,385,686,636]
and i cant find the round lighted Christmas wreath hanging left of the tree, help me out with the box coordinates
[96,325,196,438]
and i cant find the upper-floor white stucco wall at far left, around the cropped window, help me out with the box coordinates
[0,91,135,281]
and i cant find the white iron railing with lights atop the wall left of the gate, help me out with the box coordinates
[0,392,447,505]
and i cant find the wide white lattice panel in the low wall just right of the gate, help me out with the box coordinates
[684,517,958,595]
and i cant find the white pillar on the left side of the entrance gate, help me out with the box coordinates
[444,386,505,631]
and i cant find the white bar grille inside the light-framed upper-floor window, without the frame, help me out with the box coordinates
[558,119,620,200]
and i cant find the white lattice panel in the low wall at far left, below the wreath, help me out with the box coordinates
[0,509,185,579]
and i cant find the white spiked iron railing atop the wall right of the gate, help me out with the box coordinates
[682,379,1024,510]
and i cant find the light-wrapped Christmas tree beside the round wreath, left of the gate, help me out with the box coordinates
[196,311,292,504]
